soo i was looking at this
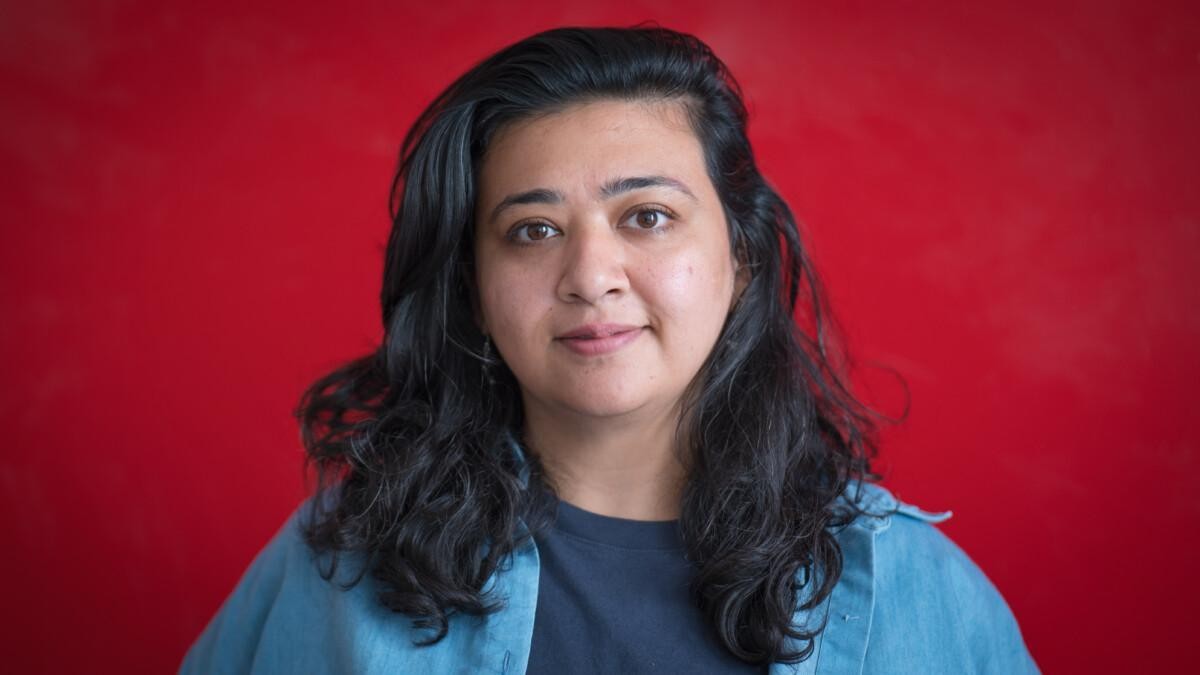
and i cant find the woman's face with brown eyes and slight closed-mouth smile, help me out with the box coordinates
[475,101,740,417]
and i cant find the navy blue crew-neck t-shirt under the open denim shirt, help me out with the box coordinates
[527,501,764,675]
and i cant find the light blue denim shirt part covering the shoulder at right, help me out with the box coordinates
[796,483,1037,673]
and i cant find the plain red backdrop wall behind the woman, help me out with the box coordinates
[0,0,1200,673]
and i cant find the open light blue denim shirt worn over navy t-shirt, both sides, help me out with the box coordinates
[180,475,1038,675]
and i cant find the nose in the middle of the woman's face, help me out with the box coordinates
[558,220,629,305]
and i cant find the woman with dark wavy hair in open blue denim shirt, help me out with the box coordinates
[184,23,1037,673]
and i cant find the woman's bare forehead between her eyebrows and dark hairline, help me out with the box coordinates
[479,100,707,196]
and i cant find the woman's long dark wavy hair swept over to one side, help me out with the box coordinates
[296,26,877,664]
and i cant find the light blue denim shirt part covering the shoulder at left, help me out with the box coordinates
[180,498,538,674]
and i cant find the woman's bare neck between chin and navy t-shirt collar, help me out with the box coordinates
[524,393,686,520]
